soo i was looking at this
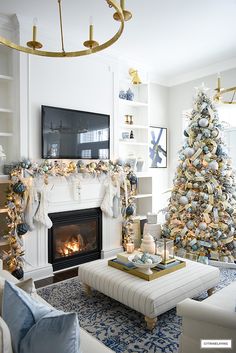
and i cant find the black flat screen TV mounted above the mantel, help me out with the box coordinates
[42,105,110,159]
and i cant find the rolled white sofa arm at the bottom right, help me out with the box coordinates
[177,299,236,329]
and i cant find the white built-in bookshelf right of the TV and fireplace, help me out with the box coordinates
[114,79,153,219]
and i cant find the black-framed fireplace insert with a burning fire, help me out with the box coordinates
[48,208,102,271]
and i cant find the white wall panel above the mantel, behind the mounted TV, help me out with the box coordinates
[28,55,113,159]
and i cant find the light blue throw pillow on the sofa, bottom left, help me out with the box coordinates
[2,281,79,353]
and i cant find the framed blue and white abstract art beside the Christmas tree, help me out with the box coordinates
[148,126,167,168]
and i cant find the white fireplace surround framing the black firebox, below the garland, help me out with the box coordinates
[24,176,122,279]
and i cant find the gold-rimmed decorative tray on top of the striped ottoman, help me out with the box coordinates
[108,259,186,281]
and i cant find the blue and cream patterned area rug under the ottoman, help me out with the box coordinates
[37,269,236,353]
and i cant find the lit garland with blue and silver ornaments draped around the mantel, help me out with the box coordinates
[1,160,137,279]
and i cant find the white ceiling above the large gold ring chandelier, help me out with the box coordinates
[0,0,236,82]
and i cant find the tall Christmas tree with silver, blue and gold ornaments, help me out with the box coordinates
[163,88,236,264]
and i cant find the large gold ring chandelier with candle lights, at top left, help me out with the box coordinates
[0,0,132,58]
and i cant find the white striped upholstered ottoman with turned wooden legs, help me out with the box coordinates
[79,260,220,329]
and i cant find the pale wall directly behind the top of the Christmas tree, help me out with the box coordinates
[168,69,236,186]
